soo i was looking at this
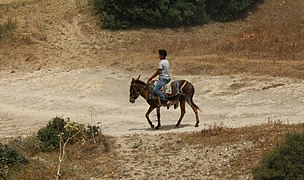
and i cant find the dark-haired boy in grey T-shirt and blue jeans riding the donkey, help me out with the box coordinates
[147,49,172,109]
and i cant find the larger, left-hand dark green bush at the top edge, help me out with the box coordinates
[94,0,208,29]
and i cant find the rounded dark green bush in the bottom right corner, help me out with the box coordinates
[253,132,304,180]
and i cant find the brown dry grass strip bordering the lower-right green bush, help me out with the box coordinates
[177,122,304,179]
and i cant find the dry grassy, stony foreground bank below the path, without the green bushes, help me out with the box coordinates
[2,121,304,179]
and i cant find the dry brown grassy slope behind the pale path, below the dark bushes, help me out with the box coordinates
[0,0,304,78]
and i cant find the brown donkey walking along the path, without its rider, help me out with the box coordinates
[130,76,199,129]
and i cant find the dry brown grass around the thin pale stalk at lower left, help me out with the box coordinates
[10,135,117,179]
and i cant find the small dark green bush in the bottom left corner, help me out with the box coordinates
[0,143,28,179]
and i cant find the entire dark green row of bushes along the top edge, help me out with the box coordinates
[94,0,260,29]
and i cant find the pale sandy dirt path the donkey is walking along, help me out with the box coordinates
[0,69,304,137]
